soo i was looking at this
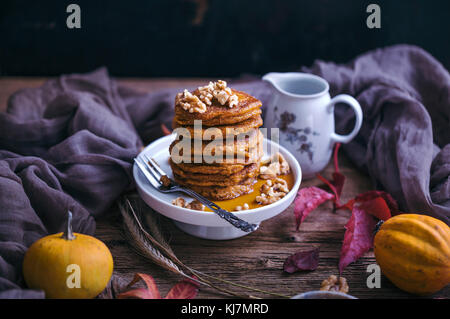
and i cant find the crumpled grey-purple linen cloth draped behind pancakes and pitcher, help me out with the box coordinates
[0,46,450,298]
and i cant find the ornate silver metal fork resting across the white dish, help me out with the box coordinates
[134,154,258,232]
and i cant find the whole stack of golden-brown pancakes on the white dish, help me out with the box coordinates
[170,85,263,200]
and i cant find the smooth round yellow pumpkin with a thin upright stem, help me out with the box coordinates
[23,212,113,299]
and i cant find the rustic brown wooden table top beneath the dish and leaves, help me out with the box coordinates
[0,78,450,298]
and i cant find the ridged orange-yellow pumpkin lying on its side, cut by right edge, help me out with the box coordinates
[374,214,450,295]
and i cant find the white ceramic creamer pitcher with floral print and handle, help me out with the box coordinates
[262,72,363,178]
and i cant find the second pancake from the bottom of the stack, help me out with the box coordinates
[170,162,259,186]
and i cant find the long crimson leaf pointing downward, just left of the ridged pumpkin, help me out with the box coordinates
[339,205,377,273]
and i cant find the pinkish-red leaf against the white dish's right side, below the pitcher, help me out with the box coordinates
[294,186,334,230]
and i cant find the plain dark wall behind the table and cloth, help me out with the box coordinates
[0,0,450,77]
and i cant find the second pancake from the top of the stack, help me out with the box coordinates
[172,115,263,140]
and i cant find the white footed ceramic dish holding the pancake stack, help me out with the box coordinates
[133,135,302,240]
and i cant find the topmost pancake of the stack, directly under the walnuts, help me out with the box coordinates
[174,89,261,126]
